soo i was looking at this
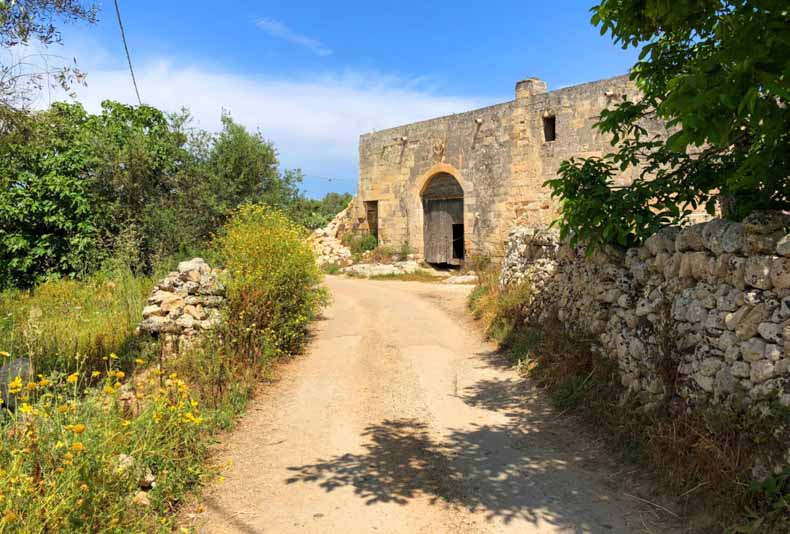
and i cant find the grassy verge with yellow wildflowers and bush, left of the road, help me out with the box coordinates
[0,207,326,532]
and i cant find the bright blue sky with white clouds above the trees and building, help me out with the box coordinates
[44,0,635,196]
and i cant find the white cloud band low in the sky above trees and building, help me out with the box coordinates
[55,59,498,195]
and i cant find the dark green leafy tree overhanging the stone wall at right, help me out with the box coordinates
[547,0,790,252]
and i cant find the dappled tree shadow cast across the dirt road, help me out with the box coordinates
[287,374,644,532]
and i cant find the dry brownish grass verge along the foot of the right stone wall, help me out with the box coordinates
[469,272,790,533]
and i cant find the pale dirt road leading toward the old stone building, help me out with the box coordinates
[201,277,666,534]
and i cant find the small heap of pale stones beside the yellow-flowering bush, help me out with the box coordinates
[139,258,225,348]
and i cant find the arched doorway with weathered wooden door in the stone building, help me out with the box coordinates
[422,172,464,265]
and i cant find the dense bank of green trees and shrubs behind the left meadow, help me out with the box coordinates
[0,102,345,288]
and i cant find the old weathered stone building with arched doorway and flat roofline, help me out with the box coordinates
[346,76,660,264]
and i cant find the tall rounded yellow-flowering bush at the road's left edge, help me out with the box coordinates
[217,205,326,362]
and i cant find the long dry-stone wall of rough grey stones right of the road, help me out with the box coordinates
[500,213,790,405]
